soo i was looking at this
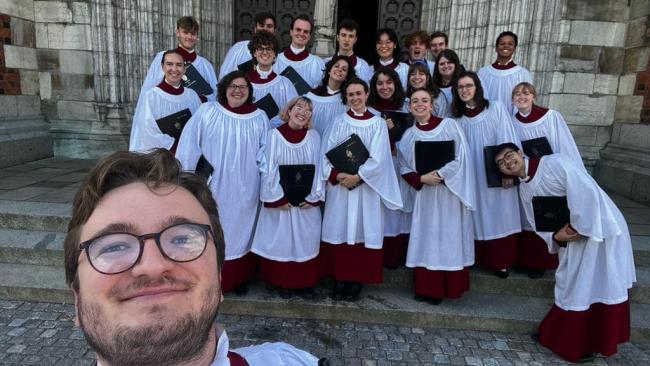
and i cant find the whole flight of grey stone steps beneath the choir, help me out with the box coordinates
[0,199,650,343]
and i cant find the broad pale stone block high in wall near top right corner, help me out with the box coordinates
[569,20,625,47]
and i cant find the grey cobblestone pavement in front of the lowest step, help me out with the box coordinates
[0,300,650,366]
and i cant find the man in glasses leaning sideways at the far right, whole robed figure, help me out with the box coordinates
[495,144,636,362]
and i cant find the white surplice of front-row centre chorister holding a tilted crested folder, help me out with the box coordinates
[321,113,402,249]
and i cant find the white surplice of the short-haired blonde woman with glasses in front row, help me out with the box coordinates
[251,129,325,262]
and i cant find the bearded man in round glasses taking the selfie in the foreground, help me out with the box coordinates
[64,149,319,366]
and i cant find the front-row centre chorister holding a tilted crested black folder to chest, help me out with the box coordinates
[320,78,402,300]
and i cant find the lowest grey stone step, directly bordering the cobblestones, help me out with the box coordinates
[0,264,650,344]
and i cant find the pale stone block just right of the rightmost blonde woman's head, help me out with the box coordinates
[549,94,616,126]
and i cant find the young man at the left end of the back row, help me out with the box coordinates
[138,16,217,102]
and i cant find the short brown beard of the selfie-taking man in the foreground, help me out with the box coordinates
[77,278,220,366]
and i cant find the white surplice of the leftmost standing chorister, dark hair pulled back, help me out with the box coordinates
[129,87,201,152]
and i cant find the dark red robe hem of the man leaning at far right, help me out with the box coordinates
[539,300,630,362]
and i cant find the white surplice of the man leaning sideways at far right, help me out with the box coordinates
[519,154,636,311]
